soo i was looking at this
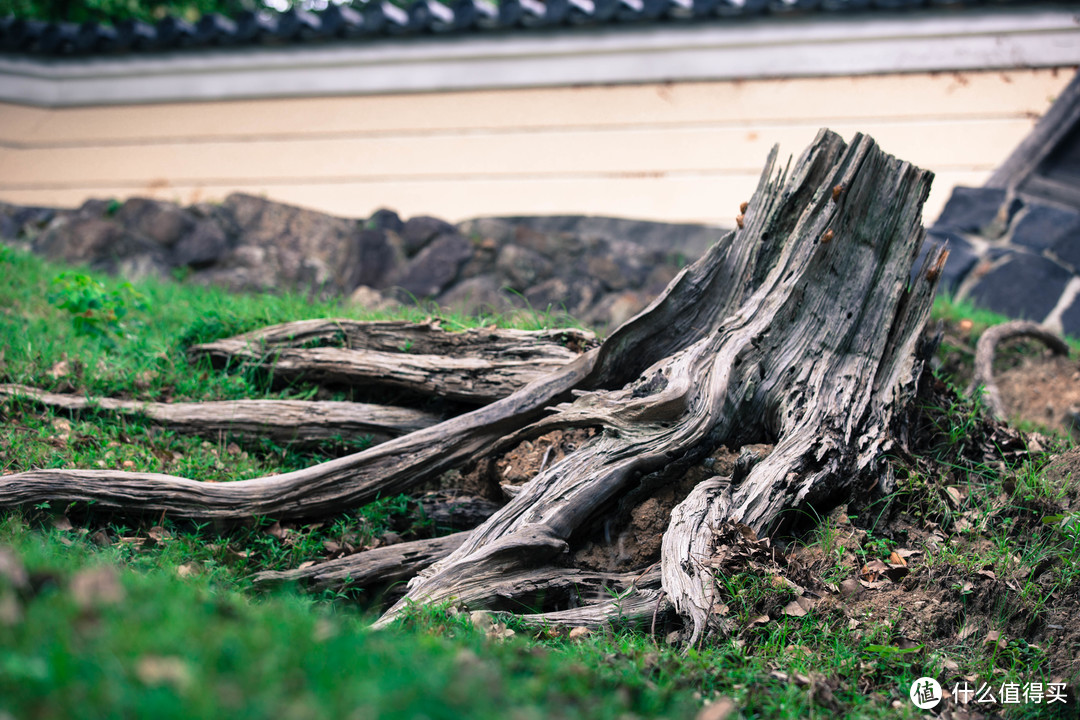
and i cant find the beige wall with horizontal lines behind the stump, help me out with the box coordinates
[0,69,1072,226]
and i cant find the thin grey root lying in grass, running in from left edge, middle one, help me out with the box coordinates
[0,384,440,444]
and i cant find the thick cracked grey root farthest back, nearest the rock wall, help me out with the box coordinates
[190,320,597,404]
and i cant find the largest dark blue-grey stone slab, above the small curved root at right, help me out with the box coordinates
[970,253,1072,322]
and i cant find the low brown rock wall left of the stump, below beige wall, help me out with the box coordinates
[0,194,723,327]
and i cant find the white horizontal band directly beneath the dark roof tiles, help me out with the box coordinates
[0,8,1080,106]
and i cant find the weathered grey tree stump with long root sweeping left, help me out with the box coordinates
[0,131,945,640]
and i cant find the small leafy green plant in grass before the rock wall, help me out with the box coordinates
[49,272,145,339]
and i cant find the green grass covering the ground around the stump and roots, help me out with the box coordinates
[0,249,1080,719]
